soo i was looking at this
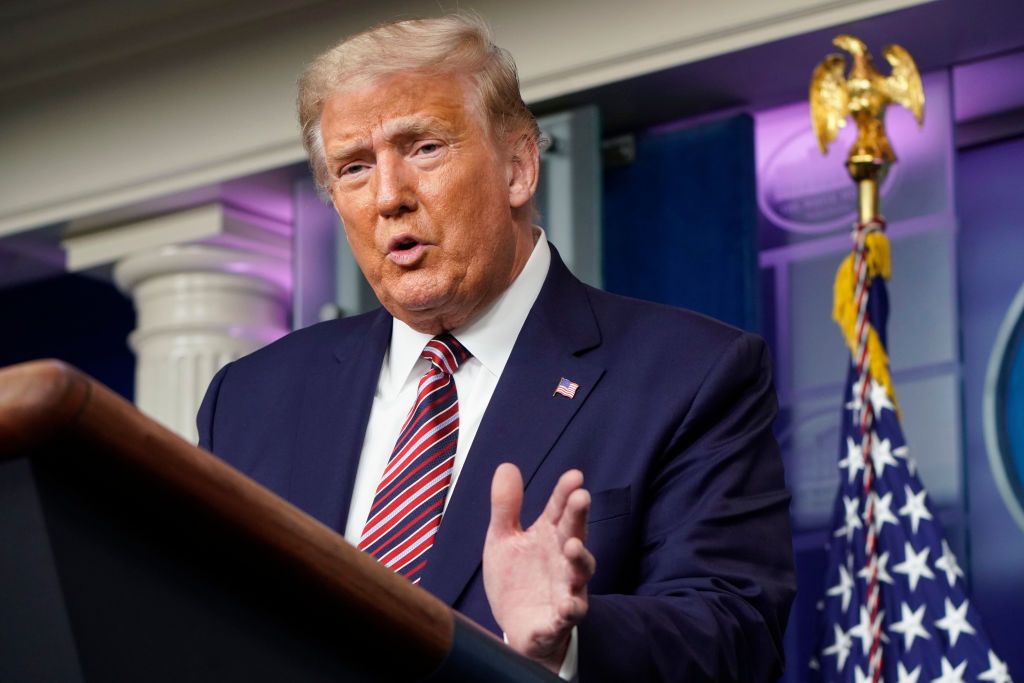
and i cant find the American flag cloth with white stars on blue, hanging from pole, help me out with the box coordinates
[810,228,1011,683]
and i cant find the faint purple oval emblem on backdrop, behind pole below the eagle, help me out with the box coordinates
[758,124,899,233]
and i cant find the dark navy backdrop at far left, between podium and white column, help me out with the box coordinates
[0,274,135,400]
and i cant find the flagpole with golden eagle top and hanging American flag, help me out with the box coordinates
[809,36,1011,683]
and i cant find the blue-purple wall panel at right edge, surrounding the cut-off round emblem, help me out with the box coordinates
[956,137,1024,681]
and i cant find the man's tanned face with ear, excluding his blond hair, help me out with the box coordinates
[321,73,536,334]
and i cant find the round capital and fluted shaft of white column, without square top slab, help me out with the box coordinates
[114,245,291,442]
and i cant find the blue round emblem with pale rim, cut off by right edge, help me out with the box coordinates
[982,286,1024,529]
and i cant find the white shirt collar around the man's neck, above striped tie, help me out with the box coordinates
[380,227,551,395]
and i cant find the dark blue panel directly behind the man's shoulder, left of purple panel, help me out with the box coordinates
[603,115,760,331]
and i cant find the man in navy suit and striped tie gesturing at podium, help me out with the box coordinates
[199,15,794,681]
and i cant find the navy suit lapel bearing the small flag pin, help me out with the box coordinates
[421,248,604,604]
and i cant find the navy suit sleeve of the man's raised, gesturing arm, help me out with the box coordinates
[579,335,796,683]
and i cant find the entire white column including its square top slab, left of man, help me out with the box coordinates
[62,202,292,442]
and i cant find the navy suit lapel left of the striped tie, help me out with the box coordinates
[289,309,391,533]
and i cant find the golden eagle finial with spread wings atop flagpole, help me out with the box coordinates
[810,34,925,166]
